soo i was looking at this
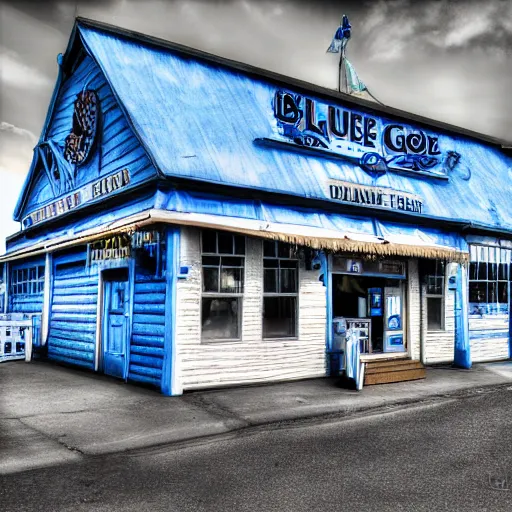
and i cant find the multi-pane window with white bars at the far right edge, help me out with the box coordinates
[469,246,512,315]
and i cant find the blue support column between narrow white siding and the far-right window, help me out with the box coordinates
[453,265,471,369]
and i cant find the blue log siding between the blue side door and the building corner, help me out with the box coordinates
[128,279,166,387]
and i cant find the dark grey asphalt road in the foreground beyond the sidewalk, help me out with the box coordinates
[0,388,512,512]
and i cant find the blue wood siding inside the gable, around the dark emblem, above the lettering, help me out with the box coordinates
[22,52,156,224]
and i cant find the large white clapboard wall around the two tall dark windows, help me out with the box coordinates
[176,228,326,390]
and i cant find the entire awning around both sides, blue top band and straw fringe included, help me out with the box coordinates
[0,190,468,262]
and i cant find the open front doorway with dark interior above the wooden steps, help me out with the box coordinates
[332,274,406,354]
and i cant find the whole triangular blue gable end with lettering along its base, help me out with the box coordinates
[14,26,156,227]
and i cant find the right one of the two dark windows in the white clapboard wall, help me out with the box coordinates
[263,241,298,338]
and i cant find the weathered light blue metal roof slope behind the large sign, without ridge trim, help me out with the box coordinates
[79,22,512,231]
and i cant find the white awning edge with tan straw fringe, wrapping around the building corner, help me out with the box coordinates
[0,209,469,263]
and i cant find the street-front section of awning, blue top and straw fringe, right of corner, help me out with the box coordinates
[162,191,468,262]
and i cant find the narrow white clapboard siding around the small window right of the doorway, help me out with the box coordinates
[422,278,455,364]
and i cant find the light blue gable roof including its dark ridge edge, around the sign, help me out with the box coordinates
[10,18,512,237]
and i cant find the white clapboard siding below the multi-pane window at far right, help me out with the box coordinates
[469,315,509,363]
